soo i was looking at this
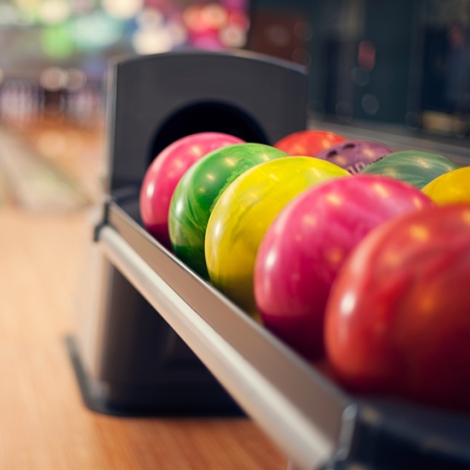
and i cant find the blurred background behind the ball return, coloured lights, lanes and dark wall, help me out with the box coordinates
[0,0,470,211]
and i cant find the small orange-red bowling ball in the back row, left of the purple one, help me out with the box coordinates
[274,130,346,157]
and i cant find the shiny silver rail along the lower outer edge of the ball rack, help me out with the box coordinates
[99,226,354,470]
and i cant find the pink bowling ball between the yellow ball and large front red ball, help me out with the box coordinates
[254,175,434,361]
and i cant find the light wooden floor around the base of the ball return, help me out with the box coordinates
[0,118,286,470]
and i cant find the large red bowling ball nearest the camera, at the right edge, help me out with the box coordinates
[325,204,470,411]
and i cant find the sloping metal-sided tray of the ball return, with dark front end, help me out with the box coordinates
[95,188,470,470]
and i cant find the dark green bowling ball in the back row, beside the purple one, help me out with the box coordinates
[360,150,459,189]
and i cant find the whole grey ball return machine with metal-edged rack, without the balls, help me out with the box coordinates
[67,51,470,470]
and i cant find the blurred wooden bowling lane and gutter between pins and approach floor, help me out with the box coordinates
[0,119,104,212]
